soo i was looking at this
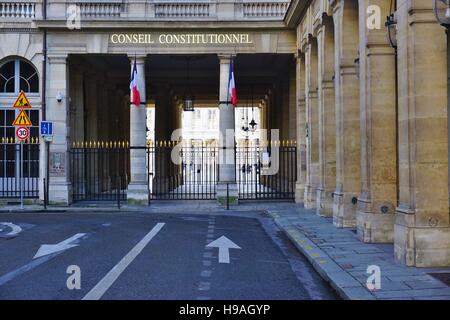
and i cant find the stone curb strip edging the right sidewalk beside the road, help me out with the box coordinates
[267,210,375,300]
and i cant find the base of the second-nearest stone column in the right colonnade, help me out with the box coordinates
[356,194,395,243]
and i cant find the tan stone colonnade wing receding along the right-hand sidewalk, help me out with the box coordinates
[285,0,450,266]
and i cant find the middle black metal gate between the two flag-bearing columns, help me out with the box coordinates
[147,141,218,200]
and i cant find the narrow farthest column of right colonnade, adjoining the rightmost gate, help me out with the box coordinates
[295,52,306,203]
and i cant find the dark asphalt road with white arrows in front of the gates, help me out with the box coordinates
[0,211,336,300]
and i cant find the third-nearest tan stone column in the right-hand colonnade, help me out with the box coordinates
[331,0,360,227]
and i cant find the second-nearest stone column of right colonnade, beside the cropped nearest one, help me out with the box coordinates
[356,0,397,243]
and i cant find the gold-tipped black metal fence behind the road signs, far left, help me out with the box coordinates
[0,138,39,198]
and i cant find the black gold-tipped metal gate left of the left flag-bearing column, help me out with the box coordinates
[70,142,130,202]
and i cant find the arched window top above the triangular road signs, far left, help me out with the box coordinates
[0,59,39,94]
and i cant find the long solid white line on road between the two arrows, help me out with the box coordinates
[83,223,165,300]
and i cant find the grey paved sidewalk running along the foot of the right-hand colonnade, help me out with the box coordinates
[268,205,450,300]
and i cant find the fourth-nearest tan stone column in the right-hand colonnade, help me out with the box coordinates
[316,17,336,216]
